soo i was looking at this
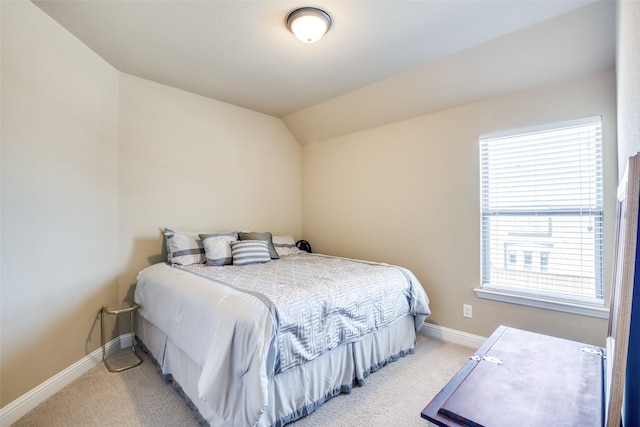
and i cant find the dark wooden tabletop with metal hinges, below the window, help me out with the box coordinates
[421,326,604,427]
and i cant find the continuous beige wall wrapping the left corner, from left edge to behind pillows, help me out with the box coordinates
[0,1,302,406]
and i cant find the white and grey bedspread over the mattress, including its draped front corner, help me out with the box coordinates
[135,254,429,425]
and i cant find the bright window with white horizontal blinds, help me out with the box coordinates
[480,117,604,307]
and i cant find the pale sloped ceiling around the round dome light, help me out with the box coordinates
[33,0,615,144]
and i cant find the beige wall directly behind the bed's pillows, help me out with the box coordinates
[119,74,302,299]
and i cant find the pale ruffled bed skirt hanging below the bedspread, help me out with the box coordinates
[136,315,416,427]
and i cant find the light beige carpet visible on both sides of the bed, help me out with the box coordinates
[13,335,473,427]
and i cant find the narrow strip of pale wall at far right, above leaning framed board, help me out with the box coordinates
[616,0,640,175]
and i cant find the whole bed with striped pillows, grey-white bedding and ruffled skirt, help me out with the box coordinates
[135,230,430,427]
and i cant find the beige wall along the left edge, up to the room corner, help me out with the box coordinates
[0,1,119,406]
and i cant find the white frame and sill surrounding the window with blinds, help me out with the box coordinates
[474,116,608,318]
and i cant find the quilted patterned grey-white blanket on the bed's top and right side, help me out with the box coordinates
[179,254,429,374]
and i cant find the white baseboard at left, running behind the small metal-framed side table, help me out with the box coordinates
[0,334,132,426]
